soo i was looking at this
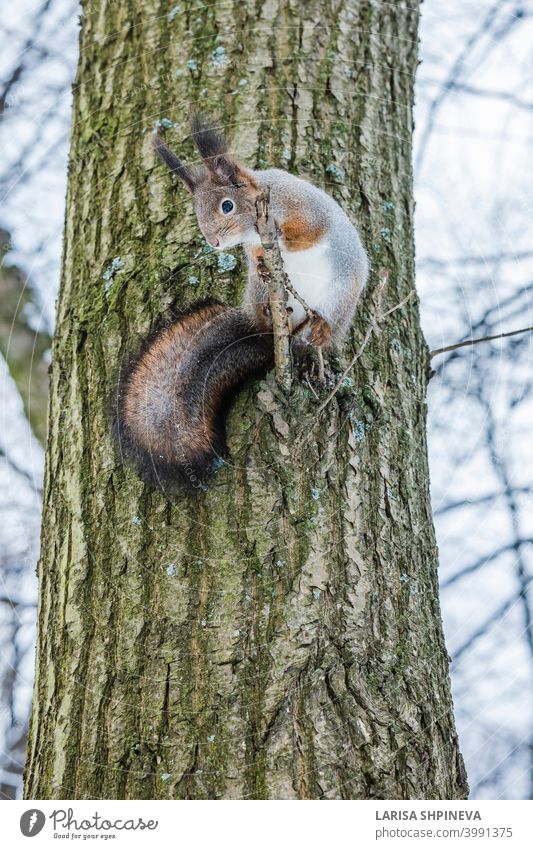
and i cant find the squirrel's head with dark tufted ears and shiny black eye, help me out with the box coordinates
[153,117,259,249]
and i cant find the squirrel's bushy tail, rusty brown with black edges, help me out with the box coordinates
[114,301,273,488]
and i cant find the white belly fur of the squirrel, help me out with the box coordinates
[281,241,333,325]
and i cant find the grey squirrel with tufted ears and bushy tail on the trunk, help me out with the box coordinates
[115,116,368,488]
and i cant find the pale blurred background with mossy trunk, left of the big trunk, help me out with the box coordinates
[0,0,78,799]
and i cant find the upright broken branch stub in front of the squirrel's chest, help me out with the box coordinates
[255,186,292,392]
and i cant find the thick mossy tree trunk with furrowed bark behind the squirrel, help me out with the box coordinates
[25,0,467,799]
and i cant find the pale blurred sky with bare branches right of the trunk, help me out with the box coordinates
[414,0,533,799]
